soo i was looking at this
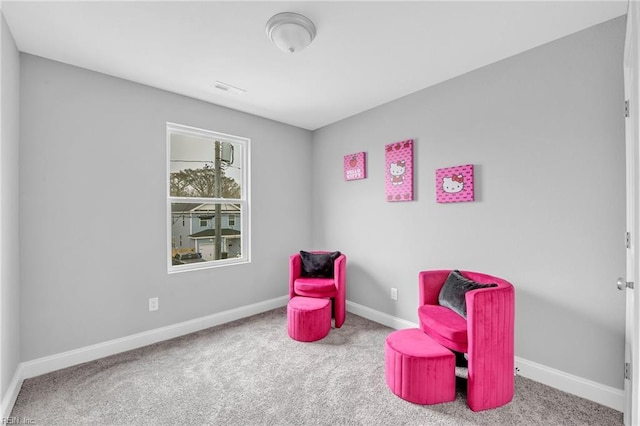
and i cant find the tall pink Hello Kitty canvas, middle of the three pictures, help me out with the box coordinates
[384,139,413,201]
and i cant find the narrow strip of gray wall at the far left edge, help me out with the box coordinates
[0,13,21,408]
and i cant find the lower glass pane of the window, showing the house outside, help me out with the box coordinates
[171,202,242,266]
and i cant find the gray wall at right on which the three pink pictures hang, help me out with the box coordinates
[313,18,625,389]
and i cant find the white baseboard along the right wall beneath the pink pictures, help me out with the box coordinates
[347,302,624,411]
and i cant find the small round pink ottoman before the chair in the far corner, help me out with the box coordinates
[287,296,331,342]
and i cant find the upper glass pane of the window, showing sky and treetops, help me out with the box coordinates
[169,132,244,199]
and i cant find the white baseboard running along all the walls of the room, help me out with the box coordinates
[0,296,624,418]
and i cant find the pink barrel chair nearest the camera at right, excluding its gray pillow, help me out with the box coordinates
[418,270,515,411]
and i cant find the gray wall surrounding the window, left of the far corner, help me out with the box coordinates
[20,54,311,361]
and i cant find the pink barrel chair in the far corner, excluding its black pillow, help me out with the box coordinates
[289,251,347,328]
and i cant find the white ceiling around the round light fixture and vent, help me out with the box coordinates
[0,0,627,130]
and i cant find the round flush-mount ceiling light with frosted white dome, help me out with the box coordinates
[266,12,316,53]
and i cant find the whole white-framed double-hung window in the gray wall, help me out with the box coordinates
[167,123,249,272]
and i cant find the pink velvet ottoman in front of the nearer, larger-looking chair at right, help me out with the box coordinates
[384,328,456,404]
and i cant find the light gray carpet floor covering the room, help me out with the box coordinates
[11,308,622,426]
